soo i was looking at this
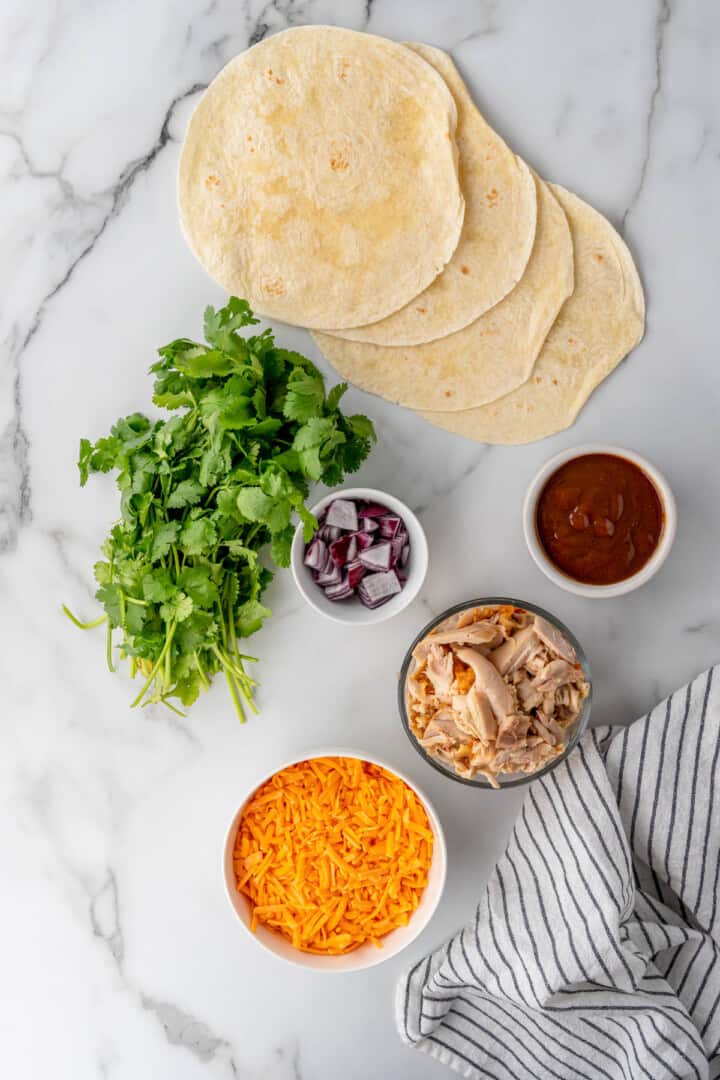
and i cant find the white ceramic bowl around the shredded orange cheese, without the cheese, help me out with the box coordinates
[222,746,448,974]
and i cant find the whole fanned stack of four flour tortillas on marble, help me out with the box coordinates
[179,27,644,443]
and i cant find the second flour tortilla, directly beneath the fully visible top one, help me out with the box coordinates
[323,44,536,346]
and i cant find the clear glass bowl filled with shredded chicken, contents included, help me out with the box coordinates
[399,596,592,787]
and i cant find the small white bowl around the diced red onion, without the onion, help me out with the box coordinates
[290,487,427,626]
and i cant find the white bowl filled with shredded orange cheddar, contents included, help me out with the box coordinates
[223,748,447,972]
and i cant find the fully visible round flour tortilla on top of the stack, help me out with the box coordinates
[178,26,464,327]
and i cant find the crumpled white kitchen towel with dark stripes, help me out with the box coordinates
[397,669,720,1080]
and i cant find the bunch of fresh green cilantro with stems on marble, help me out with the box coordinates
[65,297,375,719]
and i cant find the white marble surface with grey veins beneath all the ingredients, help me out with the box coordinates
[0,0,720,1080]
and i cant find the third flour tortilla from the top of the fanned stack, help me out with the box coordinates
[313,179,573,413]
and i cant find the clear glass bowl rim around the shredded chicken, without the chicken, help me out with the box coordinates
[397,596,593,791]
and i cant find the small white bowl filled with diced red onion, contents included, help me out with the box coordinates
[290,487,427,626]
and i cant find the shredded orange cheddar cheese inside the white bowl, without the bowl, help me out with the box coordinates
[233,757,433,956]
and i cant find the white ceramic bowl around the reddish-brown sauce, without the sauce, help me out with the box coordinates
[522,443,677,599]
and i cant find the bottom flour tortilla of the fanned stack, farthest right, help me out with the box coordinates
[422,185,644,444]
